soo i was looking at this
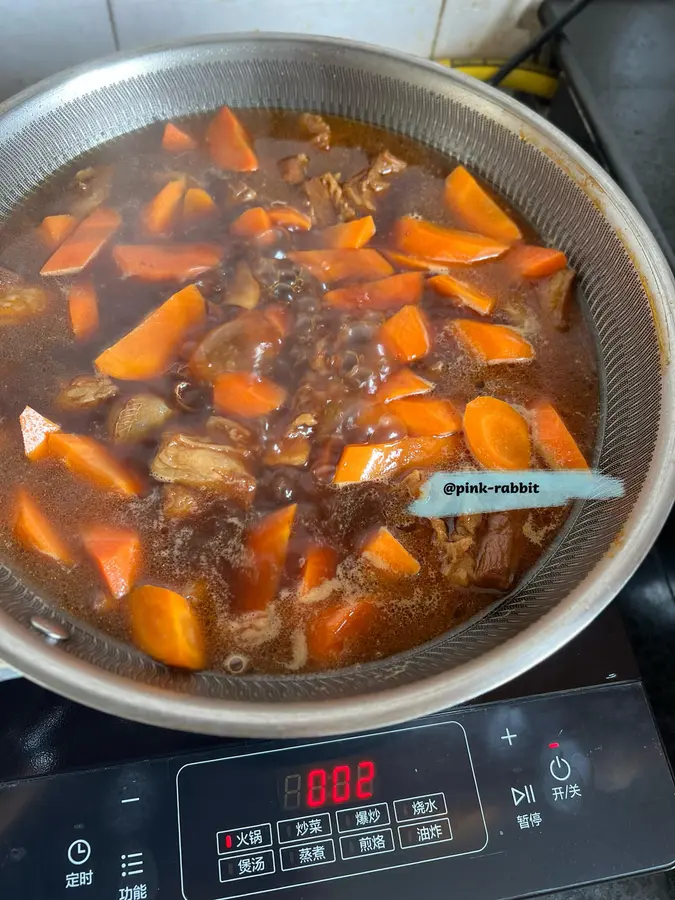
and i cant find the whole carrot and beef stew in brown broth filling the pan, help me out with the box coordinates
[0,108,597,677]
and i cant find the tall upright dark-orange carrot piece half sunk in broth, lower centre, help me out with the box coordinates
[234,503,297,612]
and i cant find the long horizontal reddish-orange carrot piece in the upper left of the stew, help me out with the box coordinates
[113,244,223,282]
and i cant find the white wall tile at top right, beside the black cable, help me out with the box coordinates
[434,0,540,59]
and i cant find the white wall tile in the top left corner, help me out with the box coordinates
[0,0,115,100]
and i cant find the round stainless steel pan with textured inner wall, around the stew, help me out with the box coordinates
[0,34,675,736]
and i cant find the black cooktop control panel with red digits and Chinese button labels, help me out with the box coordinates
[0,682,675,900]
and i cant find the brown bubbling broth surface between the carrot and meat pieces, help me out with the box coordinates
[0,110,598,673]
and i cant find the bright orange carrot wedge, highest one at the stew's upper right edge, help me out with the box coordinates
[444,166,523,244]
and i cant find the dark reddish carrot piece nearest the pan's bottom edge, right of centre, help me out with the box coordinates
[307,599,377,665]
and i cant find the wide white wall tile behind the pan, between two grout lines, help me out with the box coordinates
[112,0,442,56]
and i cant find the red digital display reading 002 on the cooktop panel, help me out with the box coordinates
[280,759,377,811]
